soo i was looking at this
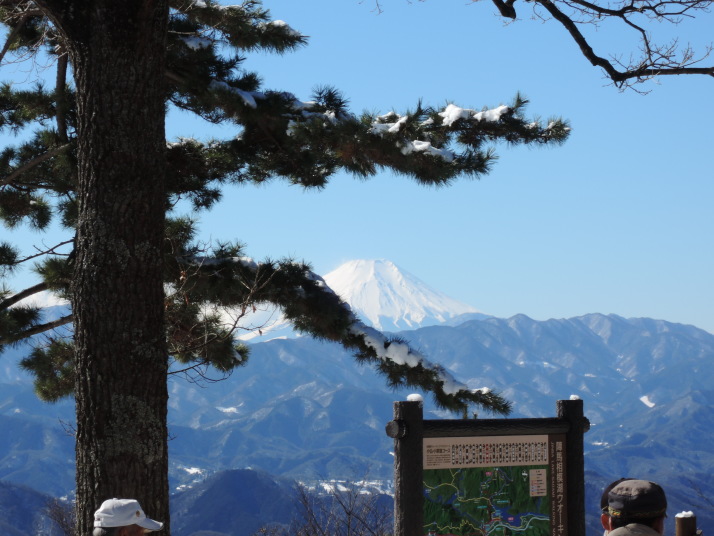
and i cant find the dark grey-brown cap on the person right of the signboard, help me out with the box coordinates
[607,480,667,520]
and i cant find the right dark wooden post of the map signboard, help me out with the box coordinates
[557,400,590,536]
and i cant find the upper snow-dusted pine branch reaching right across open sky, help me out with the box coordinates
[164,81,569,188]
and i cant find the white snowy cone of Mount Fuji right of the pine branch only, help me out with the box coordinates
[324,260,479,331]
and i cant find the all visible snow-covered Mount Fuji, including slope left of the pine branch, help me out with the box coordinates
[236,259,489,343]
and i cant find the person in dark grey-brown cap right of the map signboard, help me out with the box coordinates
[601,479,667,536]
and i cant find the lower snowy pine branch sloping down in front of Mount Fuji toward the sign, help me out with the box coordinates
[178,257,510,414]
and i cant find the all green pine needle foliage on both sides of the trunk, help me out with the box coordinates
[0,0,569,413]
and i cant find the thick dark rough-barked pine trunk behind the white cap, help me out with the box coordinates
[40,0,169,536]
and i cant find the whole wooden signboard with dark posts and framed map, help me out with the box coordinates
[386,400,590,536]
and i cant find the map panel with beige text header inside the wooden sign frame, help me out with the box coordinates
[423,436,553,536]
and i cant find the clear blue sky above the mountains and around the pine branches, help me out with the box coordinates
[5,0,714,333]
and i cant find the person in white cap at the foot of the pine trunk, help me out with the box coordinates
[92,499,164,536]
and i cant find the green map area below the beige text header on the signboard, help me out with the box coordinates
[424,465,551,536]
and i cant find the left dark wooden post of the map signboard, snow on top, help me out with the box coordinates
[386,402,424,536]
